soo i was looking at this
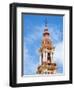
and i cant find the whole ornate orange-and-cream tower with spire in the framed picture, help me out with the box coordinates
[37,20,56,74]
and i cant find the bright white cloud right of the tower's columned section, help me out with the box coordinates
[53,42,65,73]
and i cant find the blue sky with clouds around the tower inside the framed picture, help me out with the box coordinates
[22,14,64,75]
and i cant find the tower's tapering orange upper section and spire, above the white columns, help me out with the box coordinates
[40,18,54,52]
